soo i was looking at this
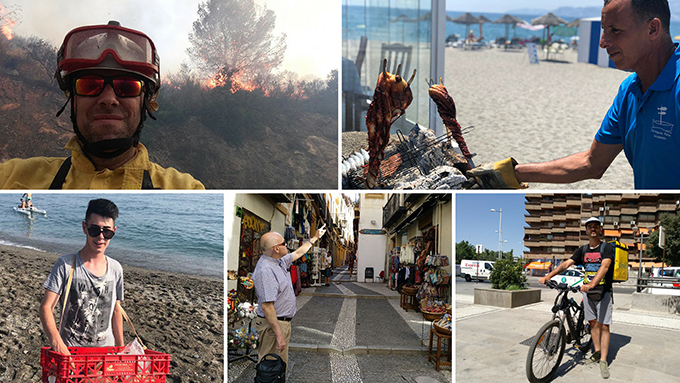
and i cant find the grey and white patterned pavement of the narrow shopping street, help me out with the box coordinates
[228,266,452,383]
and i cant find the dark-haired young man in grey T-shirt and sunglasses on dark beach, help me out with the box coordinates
[40,199,125,355]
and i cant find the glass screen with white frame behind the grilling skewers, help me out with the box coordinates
[342,0,446,136]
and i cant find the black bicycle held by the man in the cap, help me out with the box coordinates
[526,281,593,383]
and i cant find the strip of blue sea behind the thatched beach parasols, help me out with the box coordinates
[342,6,680,43]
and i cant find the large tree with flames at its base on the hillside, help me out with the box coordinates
[187,0,286,83]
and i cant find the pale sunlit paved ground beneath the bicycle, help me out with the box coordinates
[456,290,680,383]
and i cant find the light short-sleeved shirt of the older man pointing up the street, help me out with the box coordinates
[253,253,297,318]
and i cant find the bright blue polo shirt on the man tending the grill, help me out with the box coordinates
[595,44,680,189]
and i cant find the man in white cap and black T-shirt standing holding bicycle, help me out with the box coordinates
[538,217,614,379]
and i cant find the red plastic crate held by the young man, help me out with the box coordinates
[40,347,171,383]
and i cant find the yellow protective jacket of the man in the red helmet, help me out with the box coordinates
[0,136,205,190]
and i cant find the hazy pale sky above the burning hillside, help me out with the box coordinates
[6,0,341,78]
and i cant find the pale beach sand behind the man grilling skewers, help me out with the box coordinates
[444,48,633,190]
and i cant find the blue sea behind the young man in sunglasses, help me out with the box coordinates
[0,192,224,277]
